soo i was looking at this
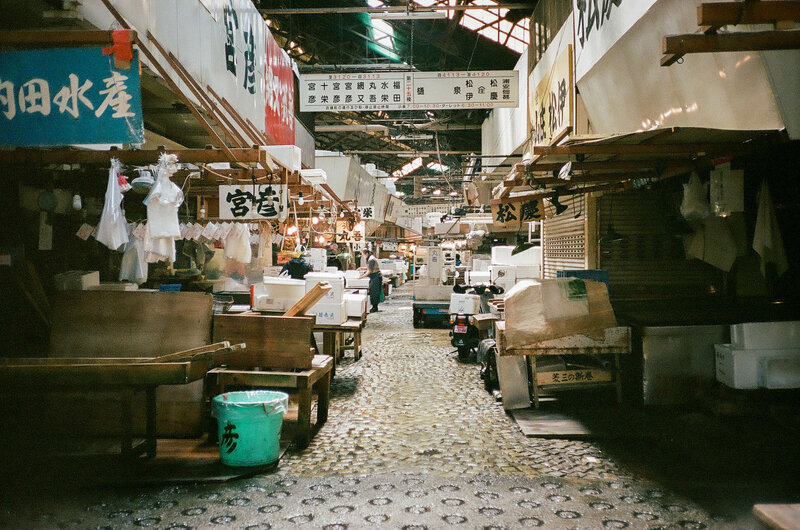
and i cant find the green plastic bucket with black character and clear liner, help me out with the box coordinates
[212,390,289,466]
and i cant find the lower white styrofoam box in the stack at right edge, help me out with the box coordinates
[714,344,800,390]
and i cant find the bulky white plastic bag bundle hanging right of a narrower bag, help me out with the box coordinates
[142,154,183,238]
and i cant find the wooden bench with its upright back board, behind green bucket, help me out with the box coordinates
[211,311,334,447]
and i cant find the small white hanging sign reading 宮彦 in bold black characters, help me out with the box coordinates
[219,184,289,220]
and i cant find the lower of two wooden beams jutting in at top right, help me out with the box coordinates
[662,30,800,55]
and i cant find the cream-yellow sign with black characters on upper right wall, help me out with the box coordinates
[530,45,574,146]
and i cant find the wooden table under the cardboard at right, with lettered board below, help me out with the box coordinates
[494,320,631,409]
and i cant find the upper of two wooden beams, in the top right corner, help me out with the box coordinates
[697,0,800,27]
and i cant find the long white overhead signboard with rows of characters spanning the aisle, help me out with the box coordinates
[300,70,519,112]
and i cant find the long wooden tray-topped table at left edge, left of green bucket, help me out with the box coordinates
[0,344,242,458]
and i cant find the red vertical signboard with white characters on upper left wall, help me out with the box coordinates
[264,31,295,145]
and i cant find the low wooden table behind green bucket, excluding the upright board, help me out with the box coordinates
[206,355,333,449]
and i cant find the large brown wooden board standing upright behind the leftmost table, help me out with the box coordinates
[50,291,212,357]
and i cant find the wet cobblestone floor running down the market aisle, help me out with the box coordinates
[0,280,800,529]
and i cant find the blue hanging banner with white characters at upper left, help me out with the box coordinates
[0,47,144,146]
